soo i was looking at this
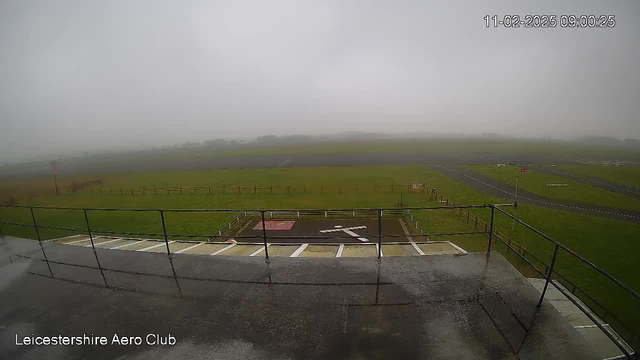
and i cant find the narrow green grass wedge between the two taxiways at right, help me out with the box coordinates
[464,165,640,210]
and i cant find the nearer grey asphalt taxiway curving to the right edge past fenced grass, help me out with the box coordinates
[427,162,640,223]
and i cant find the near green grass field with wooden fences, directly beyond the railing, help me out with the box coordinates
[0,165,640,338]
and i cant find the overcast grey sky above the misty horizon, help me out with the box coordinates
[0,0,640,161]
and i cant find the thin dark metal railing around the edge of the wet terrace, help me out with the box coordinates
[0,203,640,359]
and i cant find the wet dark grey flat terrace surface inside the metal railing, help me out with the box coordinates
[0,237,595,360]
